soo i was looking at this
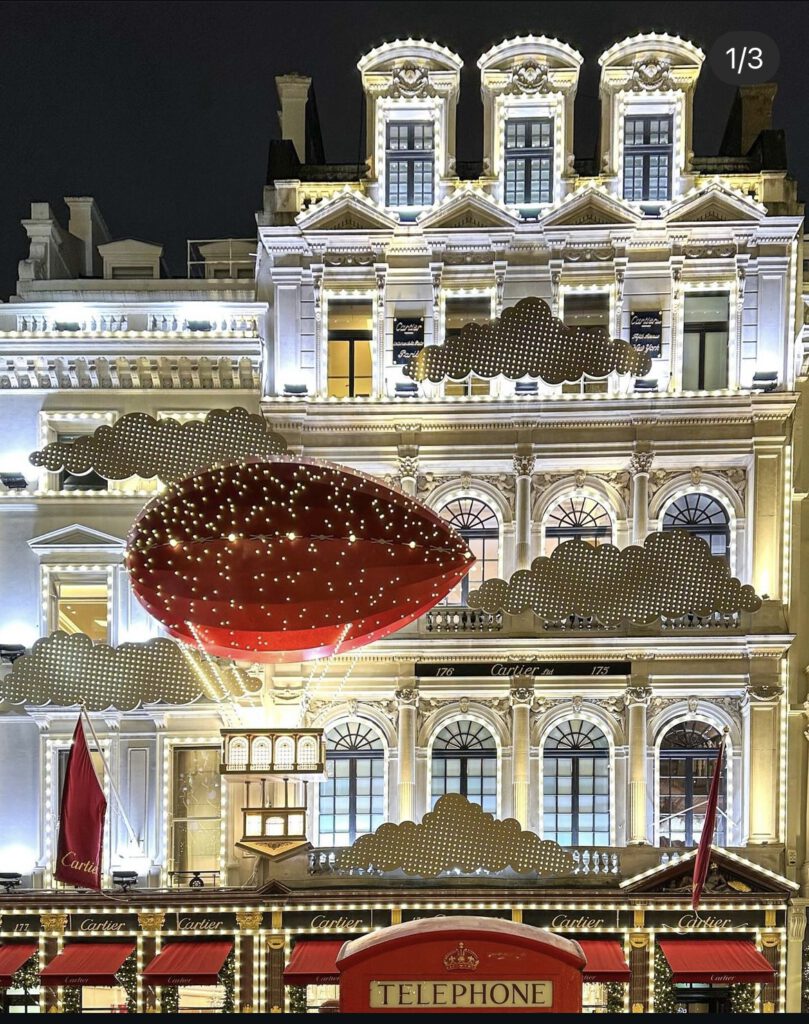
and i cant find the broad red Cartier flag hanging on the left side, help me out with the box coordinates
[53,716,107,889]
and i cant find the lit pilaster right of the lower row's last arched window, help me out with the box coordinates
[741,663,783,845]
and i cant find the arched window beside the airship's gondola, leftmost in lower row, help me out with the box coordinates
[318,722,385,846]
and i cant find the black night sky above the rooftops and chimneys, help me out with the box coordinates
[0,0,809,298]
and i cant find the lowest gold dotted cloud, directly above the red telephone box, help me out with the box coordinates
[337,793,572,878]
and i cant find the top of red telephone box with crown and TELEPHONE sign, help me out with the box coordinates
[337,918,586,1014]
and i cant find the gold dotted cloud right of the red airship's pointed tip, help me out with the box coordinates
[469,530,761,627]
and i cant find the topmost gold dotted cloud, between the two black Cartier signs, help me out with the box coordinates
[405,297,651,384]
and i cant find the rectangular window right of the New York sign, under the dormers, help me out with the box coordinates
[683,292,730,391]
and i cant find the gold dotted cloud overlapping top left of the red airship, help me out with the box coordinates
[31,407,287,483]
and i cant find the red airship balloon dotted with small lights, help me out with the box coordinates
[127,459,474,662]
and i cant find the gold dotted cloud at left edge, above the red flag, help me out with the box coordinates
[0,633,261,711]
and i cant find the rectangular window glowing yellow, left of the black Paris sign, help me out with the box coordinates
[328,301,374,398]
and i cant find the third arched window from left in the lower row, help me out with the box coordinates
[543,718,609,846]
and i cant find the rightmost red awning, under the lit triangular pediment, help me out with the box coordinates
[659,939,775,985]
